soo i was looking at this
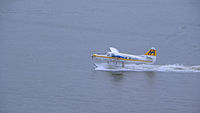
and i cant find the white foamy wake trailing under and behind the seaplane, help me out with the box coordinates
[95,63,200,72]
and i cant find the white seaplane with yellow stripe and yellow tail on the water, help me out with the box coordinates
[92,47,157,67]
